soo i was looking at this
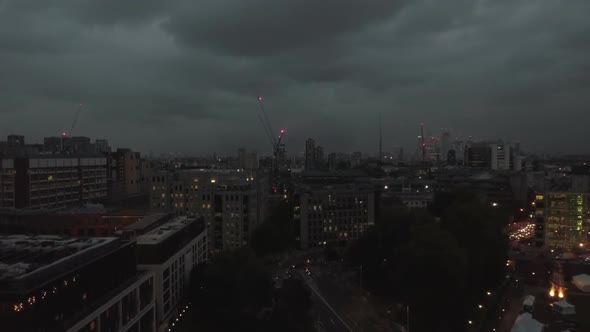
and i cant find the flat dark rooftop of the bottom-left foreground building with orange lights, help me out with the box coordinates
[0,235,116,281]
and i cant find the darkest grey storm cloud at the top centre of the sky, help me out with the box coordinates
[165,0,406,56]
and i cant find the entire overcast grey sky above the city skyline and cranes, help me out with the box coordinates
[0,0,590,154]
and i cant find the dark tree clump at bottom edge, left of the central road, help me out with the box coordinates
[189,249,313,332]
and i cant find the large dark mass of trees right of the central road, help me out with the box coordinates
[349,194,507,331]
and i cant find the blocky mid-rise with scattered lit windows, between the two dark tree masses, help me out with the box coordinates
[294,172,375,249]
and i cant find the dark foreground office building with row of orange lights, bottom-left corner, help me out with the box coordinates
[0,235,156,332]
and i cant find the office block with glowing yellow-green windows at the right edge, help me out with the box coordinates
[543,192,590,249]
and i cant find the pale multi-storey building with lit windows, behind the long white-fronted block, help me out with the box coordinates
[150,169,269,251]
